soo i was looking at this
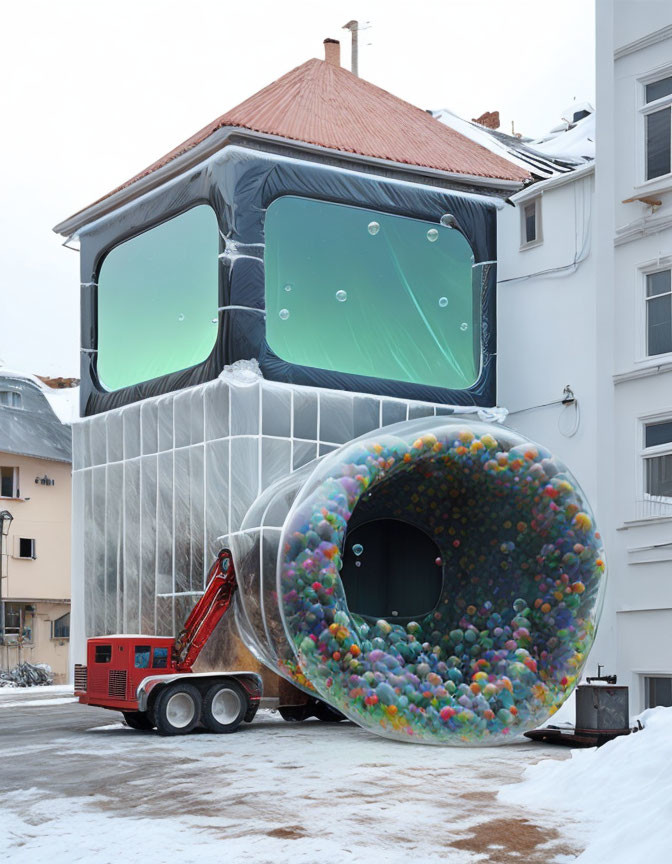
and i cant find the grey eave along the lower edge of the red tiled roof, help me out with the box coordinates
[52,126,529,238]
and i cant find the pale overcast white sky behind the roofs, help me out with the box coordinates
[0,0,595,376]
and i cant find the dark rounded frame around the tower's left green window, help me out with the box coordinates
[92,197,223,396]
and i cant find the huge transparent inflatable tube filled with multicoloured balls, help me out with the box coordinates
[232,417,605,745]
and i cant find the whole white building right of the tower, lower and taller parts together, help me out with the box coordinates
[497,0,672,713]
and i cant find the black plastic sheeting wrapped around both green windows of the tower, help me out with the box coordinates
[80,146,497,415]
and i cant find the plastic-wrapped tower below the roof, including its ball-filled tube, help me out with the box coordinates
[56,61,604,744]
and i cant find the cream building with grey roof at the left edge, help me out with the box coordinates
[0,370,71,683]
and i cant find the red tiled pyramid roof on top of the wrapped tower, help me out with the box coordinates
[69,59,530,224]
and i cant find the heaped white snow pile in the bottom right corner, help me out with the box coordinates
[498,708,672,864]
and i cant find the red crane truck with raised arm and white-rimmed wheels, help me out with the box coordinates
[75,549,262,735]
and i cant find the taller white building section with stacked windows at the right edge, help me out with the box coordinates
[595,0,672,708]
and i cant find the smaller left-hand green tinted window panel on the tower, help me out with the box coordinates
[98,205,219,390]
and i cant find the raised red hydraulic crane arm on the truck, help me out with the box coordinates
[173,549,238,672]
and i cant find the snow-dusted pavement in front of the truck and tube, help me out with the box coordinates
[0,688,580,864]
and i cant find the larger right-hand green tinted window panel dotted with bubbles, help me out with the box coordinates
[266,196,480,389]
